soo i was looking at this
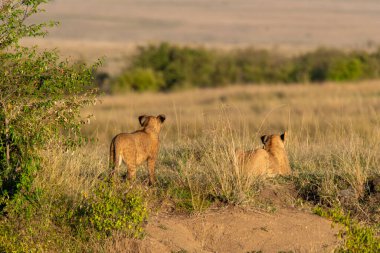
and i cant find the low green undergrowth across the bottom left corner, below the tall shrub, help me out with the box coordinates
[0,181,147,252]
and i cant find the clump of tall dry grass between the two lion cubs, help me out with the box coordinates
[153,126,263,212]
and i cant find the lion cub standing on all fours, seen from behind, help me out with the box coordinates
[110,114,165,184]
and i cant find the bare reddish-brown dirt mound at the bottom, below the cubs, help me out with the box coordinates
[107,207,338,252]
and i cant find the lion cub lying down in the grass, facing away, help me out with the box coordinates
[235,132,291,176]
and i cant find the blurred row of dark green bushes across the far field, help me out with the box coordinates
[112,43,380,93]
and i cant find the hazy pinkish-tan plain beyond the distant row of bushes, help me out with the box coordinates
[26,0,380,74]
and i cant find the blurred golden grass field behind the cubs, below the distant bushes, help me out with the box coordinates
[84,81,380,172]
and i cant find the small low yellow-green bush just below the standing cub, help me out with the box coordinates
[72,181,148,238]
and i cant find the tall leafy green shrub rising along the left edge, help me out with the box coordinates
[0,0,96,202]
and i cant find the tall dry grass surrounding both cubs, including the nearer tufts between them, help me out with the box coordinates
[37,82,380,213]
